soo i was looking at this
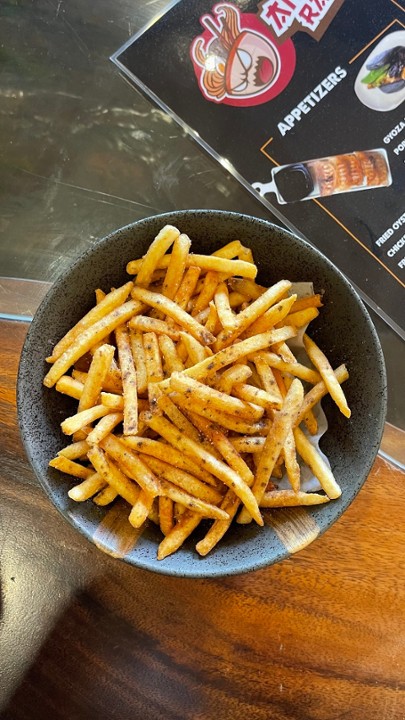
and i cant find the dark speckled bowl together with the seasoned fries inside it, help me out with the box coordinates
[17,210,386,577]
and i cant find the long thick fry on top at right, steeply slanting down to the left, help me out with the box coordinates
[238,378,304,523]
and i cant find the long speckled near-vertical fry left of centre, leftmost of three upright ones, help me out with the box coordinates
[115,325,138,435]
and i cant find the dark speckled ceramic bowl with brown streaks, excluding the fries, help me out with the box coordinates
[18,210,386,577]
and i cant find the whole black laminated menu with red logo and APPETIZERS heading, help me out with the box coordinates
[111,0,405,338]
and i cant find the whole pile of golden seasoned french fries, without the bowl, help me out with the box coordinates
[44,225,350,560]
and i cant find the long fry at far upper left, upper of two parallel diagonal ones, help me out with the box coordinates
[47,281,133,362]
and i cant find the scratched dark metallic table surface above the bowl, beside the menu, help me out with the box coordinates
[0,0,405,436]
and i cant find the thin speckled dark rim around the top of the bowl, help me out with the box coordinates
[17,209,387,579]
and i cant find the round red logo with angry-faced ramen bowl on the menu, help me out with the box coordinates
[191,3,295,106]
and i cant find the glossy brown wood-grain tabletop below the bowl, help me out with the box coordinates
[0,321,405,720]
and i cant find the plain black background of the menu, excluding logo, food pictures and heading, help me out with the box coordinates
[112,0,405,337]
